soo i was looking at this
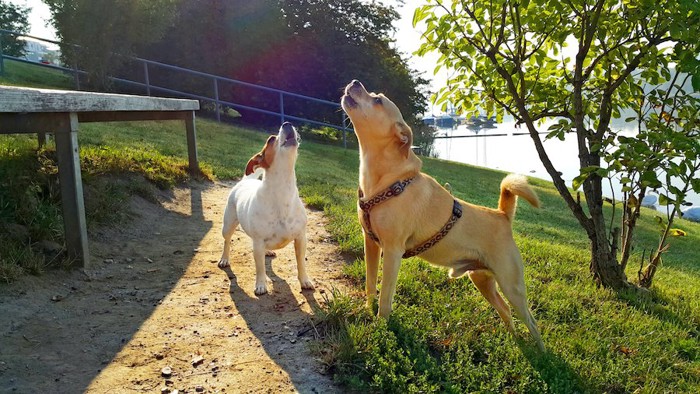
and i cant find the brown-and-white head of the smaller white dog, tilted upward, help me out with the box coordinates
[245,122,300,175]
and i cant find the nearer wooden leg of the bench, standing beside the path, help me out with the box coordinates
[54,113,90,268]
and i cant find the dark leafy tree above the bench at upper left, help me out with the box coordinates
[44,0,181,90]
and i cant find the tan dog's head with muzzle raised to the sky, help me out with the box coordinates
[341,80,413,157]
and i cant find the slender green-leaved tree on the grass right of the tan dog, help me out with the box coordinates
[414,0,700,289]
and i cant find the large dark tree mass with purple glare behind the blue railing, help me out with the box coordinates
[139,0,427,132]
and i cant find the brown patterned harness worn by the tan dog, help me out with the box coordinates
[357,177,462,258]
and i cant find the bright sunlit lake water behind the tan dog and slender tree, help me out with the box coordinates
[434,119,700,208]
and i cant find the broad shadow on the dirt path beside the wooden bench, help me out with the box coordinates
[0,183,212,393]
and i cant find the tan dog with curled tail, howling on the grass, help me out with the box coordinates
[342,81,544,349]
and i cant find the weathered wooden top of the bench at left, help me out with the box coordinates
[0,86,199,113]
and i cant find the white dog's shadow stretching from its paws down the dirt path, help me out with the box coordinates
[223,256,326,392]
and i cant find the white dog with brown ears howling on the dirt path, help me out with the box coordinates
[219,122,314,295]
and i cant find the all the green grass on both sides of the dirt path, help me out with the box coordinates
[0,62,700,393]
